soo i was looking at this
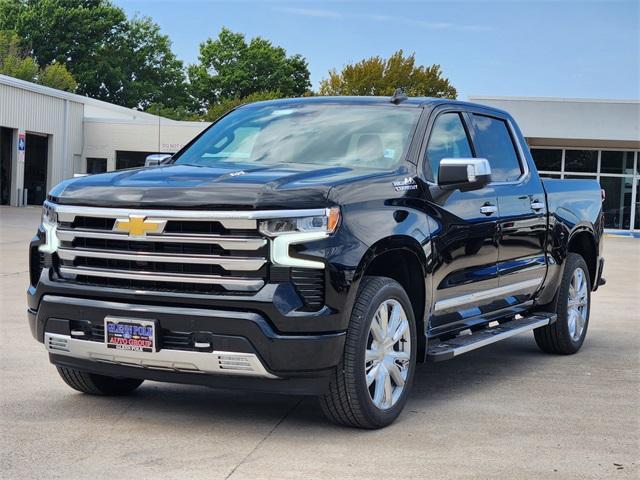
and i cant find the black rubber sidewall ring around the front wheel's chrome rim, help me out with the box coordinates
[350,278,418,426]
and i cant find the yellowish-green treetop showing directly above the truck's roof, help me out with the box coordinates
[319,50,457,98]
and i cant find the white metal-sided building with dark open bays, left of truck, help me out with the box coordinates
[0,75,209,205]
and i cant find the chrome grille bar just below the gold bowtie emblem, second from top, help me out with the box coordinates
[58,229,267,250]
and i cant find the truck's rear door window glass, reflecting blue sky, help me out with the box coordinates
[473,114,522,182]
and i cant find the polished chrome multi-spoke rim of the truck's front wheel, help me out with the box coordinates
[364,300,411,410]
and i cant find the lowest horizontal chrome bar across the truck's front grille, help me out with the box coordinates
[60,267,264,292]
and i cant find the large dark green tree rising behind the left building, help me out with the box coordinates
[0,0,186,108]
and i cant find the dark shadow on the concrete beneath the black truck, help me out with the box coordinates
[25,336,588,432]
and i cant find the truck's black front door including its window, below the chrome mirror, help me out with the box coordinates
[424,109,499,330]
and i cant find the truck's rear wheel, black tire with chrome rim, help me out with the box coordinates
[533,253,591,355]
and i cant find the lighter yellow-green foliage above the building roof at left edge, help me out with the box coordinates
[0,30,77,92]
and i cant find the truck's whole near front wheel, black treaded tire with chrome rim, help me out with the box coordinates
[320,277,417,429]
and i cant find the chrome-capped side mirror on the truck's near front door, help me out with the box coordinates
[438,158,491,191]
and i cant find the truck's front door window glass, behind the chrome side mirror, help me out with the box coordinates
[425,112,473,182]
